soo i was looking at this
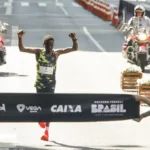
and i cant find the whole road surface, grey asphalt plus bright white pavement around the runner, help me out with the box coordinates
[0,0,150,150]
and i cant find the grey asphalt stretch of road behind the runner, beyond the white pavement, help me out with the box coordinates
[0,0,123,52]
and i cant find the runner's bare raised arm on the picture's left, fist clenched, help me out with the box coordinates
[18,30,40,54]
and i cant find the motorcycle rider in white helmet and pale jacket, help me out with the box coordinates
[124,5,150,50]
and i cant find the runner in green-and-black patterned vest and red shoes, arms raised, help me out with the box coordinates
[18,30,78,141]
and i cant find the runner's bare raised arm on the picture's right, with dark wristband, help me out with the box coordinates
[56,33,78,56]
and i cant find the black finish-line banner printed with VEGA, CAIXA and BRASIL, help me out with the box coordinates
[0,93,140,122]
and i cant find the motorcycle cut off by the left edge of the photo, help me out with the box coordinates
[0,21,9,66]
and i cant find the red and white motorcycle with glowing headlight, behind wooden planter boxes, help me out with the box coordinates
[122,19,150,72]
